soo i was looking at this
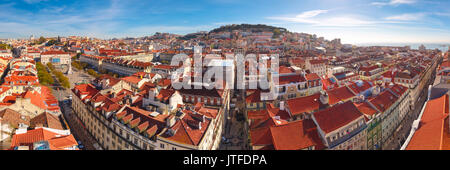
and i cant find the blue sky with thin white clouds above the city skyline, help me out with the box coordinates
[0,0,450,44]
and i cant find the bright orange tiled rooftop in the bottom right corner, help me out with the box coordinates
[401,52,450,150]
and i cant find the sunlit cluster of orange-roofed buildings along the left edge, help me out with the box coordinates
[0,47,78,150]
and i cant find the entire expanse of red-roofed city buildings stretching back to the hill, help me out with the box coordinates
[0,24,450,150]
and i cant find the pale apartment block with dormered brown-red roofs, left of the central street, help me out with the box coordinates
[72,80,229,150]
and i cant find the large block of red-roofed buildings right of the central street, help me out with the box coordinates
[246,47,442,150]
